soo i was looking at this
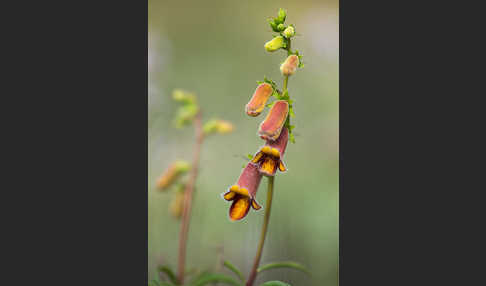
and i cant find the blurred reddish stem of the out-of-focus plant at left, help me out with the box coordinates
[177,112,204,285]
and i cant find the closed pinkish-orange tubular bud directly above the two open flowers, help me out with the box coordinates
[258,100,289,141]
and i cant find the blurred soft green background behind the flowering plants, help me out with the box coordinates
[148,0,339,286]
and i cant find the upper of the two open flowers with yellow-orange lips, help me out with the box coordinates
[251,127,289,176]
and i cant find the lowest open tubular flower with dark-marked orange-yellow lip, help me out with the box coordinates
[223,162,262,220]
